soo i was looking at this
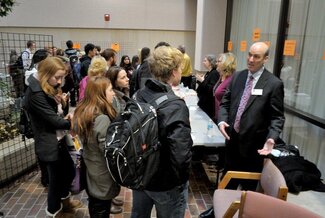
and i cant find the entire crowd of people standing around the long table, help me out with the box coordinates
[13,40,284,218]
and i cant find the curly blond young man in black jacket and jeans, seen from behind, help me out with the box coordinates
[131,46,193,218]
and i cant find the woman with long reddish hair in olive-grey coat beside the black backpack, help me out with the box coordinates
[73,76,120,218]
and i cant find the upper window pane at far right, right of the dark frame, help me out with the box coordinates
[281,0,325,119]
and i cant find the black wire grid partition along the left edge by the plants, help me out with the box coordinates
[0,32,53,196]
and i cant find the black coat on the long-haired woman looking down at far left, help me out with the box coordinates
[23,76,70,161]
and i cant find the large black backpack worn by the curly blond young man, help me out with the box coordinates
[105,93,179,190]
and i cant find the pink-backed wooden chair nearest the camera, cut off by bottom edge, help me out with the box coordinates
[224,191,321,218]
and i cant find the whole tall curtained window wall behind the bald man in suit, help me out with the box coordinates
[230,0,325,184]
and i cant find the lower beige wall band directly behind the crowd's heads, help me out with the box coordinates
[0,27,195,63]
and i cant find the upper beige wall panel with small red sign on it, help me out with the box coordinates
[0,0,196,31]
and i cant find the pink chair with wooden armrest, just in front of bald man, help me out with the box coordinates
[213,159,288,217]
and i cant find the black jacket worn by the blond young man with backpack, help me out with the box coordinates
[136,79,193,191]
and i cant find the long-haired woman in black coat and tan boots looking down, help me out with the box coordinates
[23,57,82,217]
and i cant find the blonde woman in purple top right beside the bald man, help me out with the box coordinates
[214,52,237,121]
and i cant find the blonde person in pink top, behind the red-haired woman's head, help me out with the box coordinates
[79,55,108,102]
